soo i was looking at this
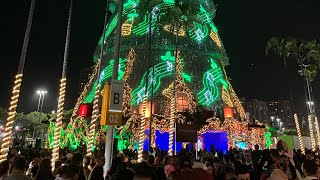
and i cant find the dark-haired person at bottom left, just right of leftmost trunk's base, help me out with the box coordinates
[6,157,32,180]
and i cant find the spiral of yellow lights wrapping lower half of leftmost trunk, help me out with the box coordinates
[0,74,23,162]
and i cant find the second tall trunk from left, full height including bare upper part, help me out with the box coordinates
[51,0,73,168]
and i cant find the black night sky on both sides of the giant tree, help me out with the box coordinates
[0,0,320,112]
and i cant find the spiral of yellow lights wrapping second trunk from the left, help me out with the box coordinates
[51,78,67,170]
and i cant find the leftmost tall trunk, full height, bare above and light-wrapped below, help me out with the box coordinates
[0,0,36,162]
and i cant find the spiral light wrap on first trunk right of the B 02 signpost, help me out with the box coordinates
[138,95,147,162]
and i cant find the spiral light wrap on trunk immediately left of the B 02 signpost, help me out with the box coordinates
[87,83,100,156]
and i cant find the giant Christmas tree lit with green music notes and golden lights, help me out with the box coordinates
[56,0,245,153]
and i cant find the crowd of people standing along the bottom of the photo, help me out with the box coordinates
[0,140,320,180]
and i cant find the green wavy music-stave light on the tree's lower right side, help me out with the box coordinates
[197,59,226,106]
